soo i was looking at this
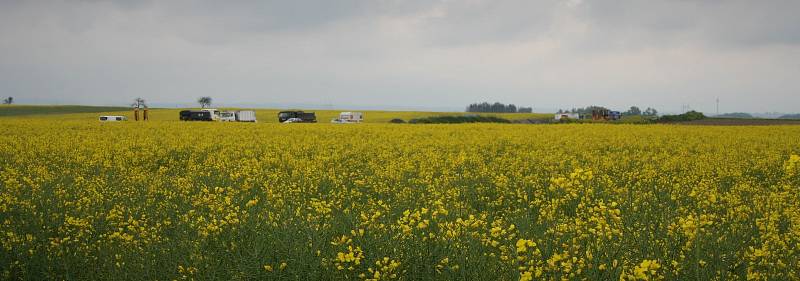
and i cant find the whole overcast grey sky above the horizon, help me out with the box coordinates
[0,0,800,113]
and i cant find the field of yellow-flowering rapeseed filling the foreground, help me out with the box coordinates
[0,113,800,280]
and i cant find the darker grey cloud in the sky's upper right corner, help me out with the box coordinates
[578,0,800,48]
